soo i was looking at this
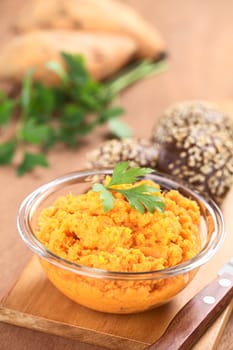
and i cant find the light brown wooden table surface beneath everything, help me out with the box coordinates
[0,0,233,350]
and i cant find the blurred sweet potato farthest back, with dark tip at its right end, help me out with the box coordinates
[14,0,165,59]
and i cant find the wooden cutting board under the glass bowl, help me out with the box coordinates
[0,185,233,350]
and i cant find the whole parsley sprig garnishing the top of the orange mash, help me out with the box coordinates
[92,161,165,214]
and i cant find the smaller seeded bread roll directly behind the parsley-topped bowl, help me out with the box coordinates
[87,139,158,168]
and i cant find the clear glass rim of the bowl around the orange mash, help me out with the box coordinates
[17,168,225,280]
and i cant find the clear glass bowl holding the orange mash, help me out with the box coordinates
[17,169,224,313]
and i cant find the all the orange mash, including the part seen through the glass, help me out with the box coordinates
[36,181,200,313]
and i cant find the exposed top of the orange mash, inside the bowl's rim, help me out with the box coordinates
[37,180,200,272]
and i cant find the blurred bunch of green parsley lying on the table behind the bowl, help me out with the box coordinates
[0,53,166,175]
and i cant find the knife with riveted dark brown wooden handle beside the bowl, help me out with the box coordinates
[144,258,233,350]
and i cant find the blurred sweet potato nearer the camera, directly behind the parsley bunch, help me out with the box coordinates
[0,30,137,85]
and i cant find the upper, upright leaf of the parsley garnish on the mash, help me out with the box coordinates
[108,161,154,186]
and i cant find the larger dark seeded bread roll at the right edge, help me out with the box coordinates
[152,102,233,204]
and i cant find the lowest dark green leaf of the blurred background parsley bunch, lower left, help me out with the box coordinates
[17,152,48,176]
